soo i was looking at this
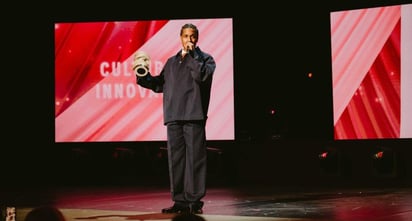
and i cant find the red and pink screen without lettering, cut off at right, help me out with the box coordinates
[330,4,412,140]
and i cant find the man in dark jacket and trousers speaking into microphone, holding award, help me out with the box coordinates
[133,23,216,214]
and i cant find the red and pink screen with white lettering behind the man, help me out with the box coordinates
[54,18,235,142]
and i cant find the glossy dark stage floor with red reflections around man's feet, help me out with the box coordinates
[1,185,412,221]
